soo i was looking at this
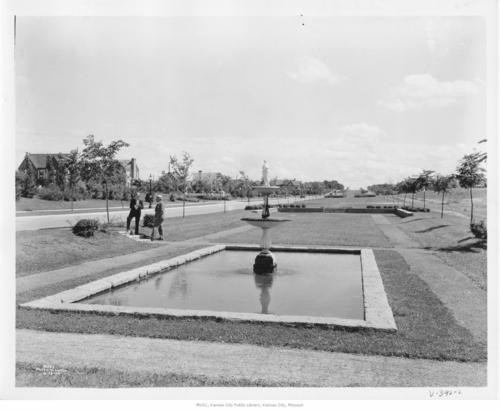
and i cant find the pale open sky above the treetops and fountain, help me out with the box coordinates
[15,15,487,189]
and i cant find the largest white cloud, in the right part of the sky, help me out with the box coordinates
[379,74,478,112]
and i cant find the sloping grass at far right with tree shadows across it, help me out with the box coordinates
[391,212,487,290]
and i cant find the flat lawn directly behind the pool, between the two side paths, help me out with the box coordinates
[218,212,392,248]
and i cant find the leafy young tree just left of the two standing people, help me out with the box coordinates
[81,135,129,223]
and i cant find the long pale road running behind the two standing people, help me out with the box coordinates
[16,196,315,231]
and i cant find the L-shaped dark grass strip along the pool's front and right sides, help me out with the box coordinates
[16,250,486,361]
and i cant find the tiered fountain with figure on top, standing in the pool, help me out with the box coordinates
[242,161,289,274]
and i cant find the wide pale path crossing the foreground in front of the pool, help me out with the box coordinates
[16,329,486,387]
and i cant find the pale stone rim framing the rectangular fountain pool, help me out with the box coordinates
[20,244,397,331]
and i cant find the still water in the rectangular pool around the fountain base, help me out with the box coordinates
[82,250,364,320]
